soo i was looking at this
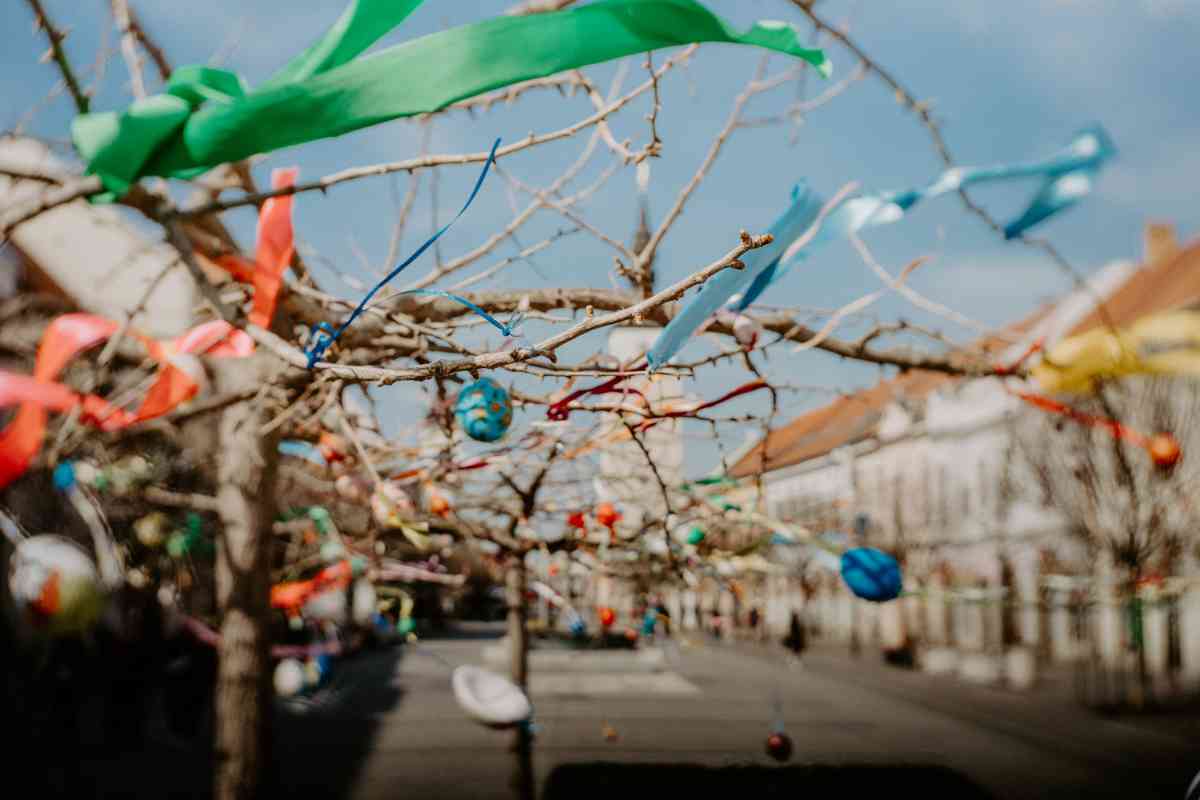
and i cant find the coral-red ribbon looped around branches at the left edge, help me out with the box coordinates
[0,168,296,488]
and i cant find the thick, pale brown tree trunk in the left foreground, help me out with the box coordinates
[214,356,278,800]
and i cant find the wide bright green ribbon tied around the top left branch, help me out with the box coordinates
[71,0,830,200]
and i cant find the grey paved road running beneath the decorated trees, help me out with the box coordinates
[277,623,1200,800]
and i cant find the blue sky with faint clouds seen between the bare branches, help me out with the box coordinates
[0,0,1200,471]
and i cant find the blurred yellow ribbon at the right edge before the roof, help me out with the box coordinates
[1030,311,1200,393]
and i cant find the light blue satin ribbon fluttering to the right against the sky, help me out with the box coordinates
[647,125,1116,369]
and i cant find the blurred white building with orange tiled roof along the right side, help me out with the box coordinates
[731,225,1200,680]
